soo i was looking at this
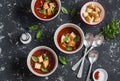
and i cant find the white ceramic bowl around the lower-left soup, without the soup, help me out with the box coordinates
[27,46,58,77]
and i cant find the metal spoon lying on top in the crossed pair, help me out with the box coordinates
[77,33,94,78]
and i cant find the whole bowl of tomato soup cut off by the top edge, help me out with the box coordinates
[31,0,61,21]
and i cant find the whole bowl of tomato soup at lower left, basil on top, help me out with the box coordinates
[27,46,58,77]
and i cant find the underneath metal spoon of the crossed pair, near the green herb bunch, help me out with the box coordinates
[72,34,104,71]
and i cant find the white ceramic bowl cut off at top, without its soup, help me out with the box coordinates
[31,0,61,21]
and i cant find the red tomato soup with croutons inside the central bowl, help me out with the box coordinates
[57,27,81,51]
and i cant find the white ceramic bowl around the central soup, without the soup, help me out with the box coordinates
[54,23,84,54]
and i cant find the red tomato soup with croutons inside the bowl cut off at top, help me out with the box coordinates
[34,0,58,19]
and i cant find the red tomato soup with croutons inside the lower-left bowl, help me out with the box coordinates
[30,49,56,74]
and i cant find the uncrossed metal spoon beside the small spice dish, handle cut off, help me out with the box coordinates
[86,50,98,81]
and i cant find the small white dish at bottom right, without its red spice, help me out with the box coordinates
[93,68,108,81]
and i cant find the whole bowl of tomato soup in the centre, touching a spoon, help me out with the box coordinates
[54,23,84,54]
